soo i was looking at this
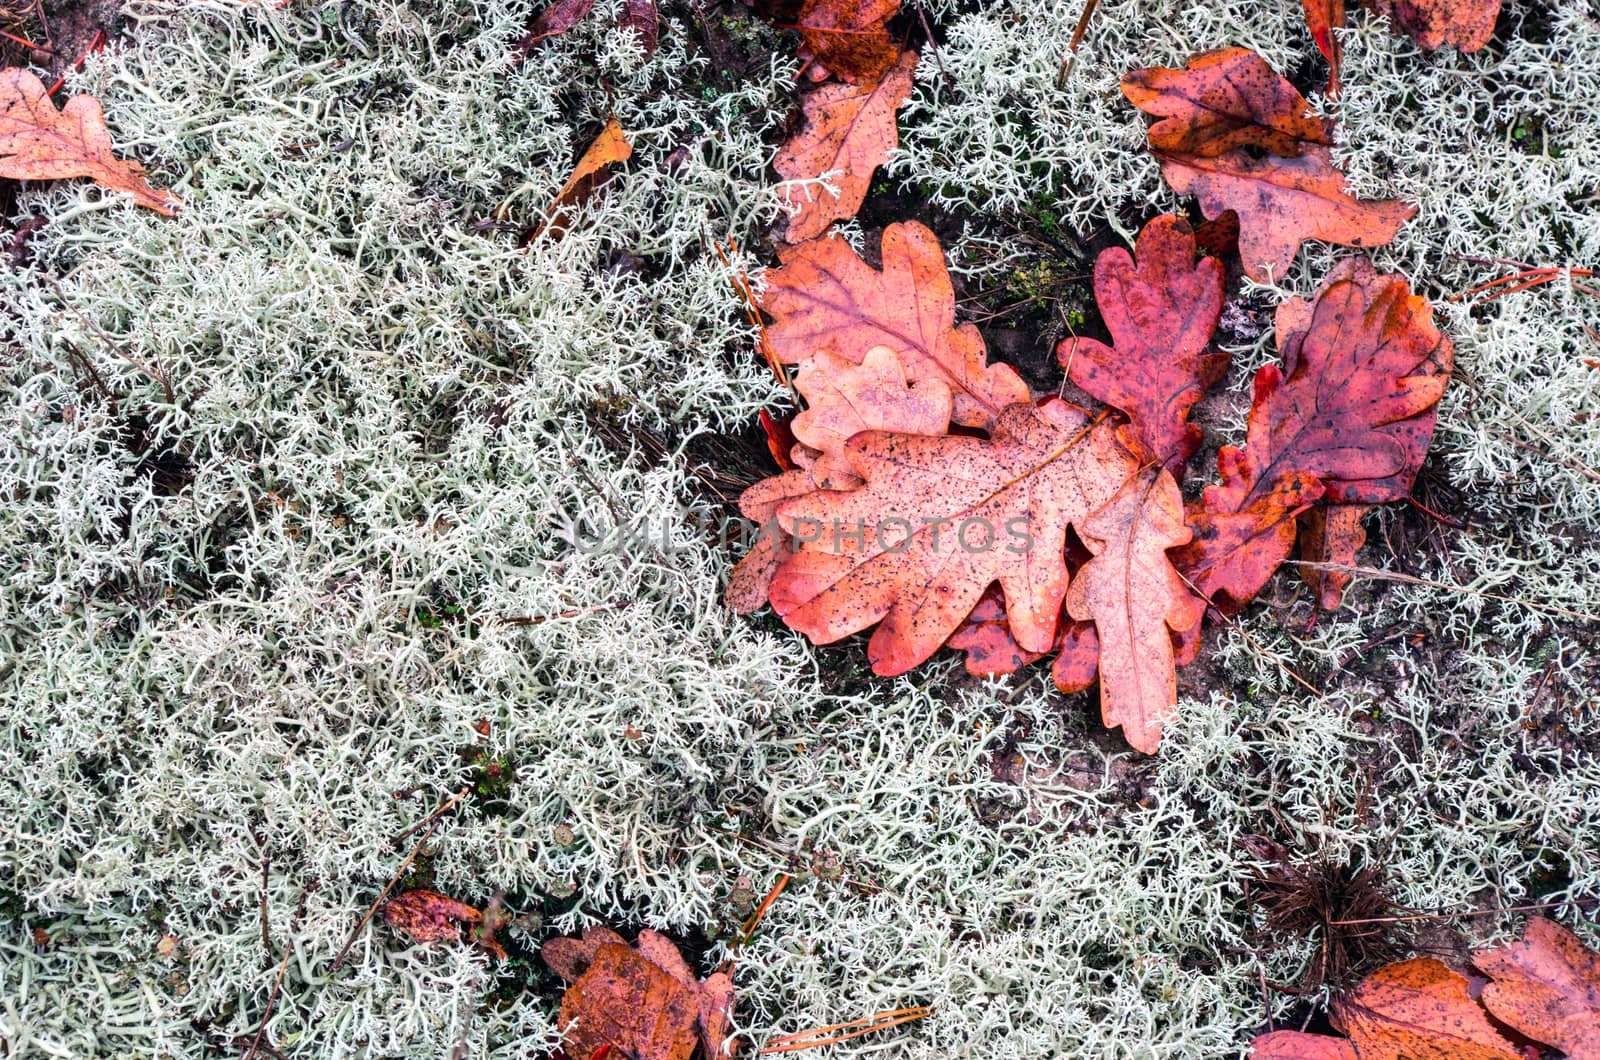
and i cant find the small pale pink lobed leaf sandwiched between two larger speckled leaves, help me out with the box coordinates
[794,346,950,490]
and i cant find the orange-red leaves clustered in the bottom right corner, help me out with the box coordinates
[1250,917,1600,1060]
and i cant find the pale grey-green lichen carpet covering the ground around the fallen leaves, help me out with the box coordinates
[0,0,1600,1060]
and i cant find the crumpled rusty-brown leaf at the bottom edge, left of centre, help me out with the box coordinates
[541,927,734,1060]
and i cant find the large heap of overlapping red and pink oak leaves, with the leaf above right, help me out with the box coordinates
[728,48,1451,753]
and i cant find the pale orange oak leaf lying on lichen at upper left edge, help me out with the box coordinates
[0,69,181,216]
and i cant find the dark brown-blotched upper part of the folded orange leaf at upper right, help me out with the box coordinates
[1122,48,1331,159]
